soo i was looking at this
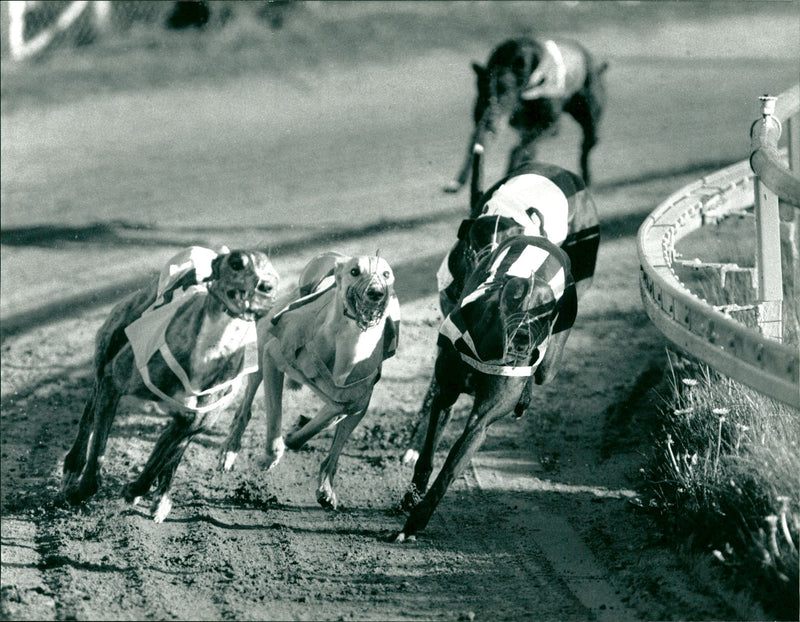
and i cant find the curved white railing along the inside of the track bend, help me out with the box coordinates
[638,87,800,408]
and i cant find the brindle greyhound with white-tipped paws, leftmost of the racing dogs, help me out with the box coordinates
[62,247,278,522]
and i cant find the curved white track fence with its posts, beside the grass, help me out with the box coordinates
[638,85,800,408]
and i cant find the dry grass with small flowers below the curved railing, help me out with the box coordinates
[645,357,800,619]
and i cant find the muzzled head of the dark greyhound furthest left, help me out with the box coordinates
[208,250,279,320]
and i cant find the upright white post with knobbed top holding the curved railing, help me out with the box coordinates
[750,95,783,341]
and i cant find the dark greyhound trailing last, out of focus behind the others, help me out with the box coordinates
[445,38,608,192]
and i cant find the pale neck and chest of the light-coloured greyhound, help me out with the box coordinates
[315,291,386,386]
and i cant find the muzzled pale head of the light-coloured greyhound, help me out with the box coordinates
[334,255,394,331]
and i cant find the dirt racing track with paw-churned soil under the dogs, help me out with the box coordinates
[2,12,796,620]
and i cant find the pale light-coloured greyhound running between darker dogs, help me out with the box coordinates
[220,253,400,509]
